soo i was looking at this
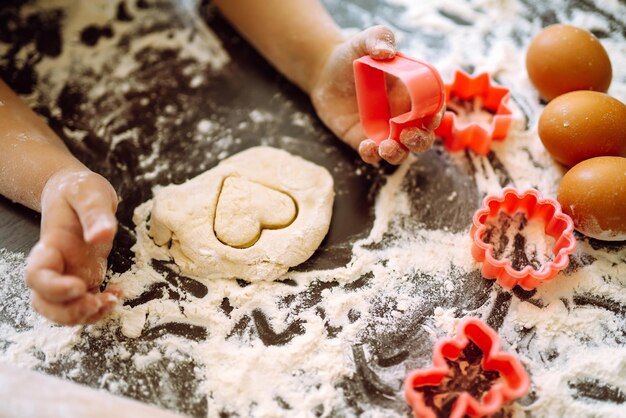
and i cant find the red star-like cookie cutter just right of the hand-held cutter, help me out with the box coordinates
[435,70,513,155]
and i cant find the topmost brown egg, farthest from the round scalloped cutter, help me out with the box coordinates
[526,25,612,100]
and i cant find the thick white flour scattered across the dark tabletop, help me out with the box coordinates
[0,0,626,417]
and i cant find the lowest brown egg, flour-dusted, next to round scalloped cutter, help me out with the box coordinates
[558,157,626,241]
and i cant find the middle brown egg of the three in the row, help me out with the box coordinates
[539,91,626,167]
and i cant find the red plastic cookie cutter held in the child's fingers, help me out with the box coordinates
[353,53,445,144]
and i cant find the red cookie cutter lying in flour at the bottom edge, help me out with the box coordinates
[404,318,530,418]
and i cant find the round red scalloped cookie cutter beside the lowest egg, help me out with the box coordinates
[471,187,576,290]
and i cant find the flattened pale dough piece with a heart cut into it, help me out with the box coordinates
[150,147,335,281]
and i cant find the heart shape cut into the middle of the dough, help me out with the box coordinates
[213,177,297,248]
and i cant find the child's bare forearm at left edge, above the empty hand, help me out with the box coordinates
[0,80,86,211]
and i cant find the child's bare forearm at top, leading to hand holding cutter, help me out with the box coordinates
[215,0,343,93]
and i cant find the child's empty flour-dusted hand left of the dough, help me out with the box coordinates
[26,170,119,325]
